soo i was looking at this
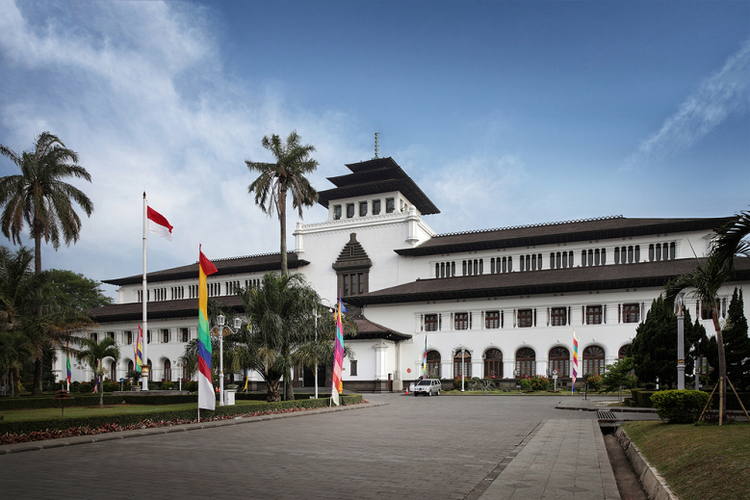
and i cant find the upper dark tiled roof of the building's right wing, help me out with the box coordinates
[395,216,729,256]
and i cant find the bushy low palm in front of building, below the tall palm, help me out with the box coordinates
[237,273,320,401]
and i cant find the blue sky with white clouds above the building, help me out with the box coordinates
[0,0,750,295]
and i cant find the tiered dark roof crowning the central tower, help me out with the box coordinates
[318,157,440,215]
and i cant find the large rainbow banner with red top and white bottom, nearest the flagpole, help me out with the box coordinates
[198,247,218,411]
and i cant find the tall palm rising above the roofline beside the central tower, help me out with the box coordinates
[245,130,318,276]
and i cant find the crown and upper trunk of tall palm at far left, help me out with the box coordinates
[0,132,94,274]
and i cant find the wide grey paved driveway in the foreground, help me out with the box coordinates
[0,394,619,500]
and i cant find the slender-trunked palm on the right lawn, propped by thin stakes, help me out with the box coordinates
[665,254,729,416]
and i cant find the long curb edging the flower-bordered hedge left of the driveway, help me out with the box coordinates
[0,403,388,455]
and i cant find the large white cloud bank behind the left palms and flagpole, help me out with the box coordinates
[0,0,361,292]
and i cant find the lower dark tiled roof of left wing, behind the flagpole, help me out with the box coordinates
[88,296,244,323]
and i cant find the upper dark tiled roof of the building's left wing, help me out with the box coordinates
[103,252,309,286]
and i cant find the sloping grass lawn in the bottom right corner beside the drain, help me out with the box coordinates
[623,421,750,500]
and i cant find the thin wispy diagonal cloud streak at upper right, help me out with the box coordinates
[624,39,750,170]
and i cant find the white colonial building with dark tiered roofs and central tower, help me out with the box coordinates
[55,158,750,391]
